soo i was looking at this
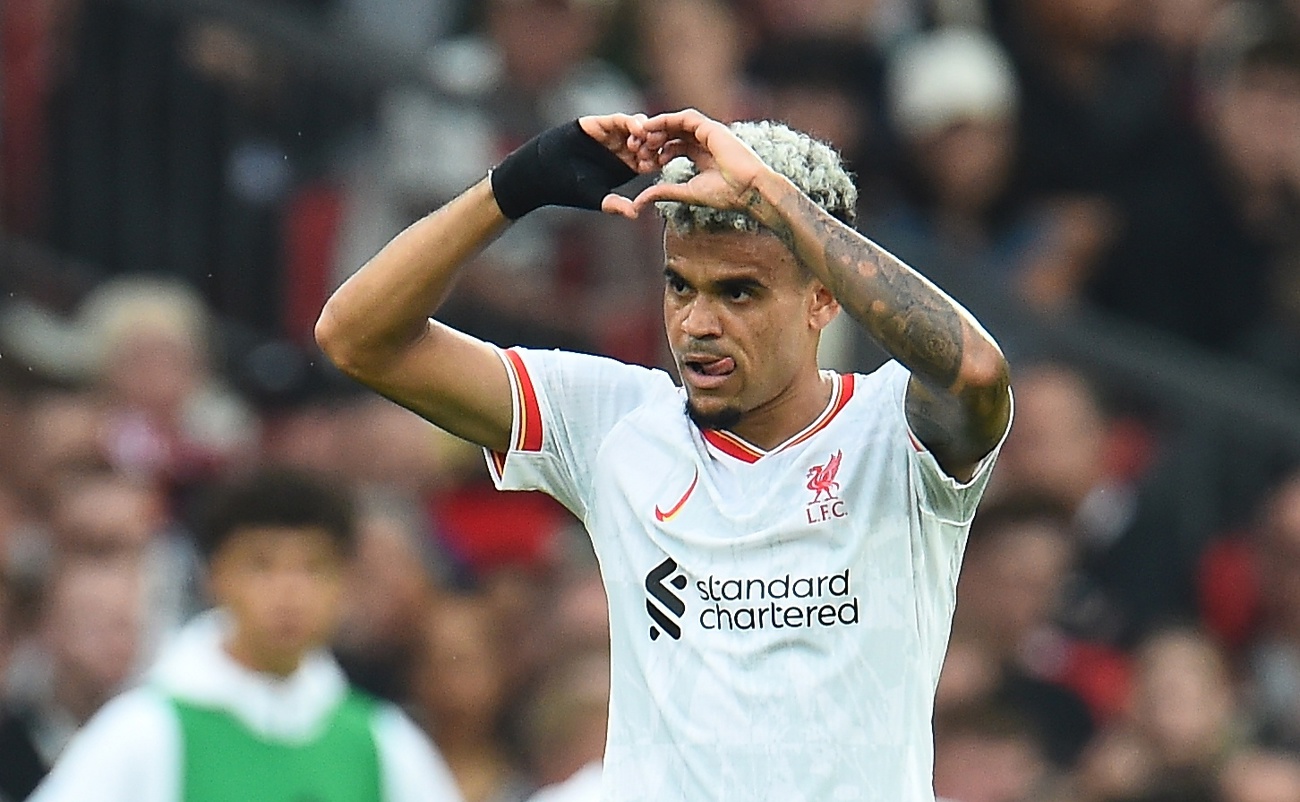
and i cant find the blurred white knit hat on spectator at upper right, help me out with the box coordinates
[888,27,1018,136]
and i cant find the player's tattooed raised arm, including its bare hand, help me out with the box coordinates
[615,110,1011,480]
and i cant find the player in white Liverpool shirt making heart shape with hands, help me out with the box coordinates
[316,110,1011,802]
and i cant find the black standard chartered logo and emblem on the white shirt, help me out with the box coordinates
[646,558,861,641]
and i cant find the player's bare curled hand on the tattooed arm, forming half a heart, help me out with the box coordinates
[600,109,774,221]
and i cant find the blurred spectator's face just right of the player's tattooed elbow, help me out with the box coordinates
[997,367,1106,508]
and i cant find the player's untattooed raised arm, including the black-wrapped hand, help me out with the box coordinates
[316,114,640,451]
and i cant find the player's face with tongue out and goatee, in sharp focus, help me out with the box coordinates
[663,229,839,437]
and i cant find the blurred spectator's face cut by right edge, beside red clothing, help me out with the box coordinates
[1258,476,1300,638]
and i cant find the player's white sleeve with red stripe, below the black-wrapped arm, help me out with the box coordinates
[485,348,676,519]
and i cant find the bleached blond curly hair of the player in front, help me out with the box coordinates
[655,120,858,234]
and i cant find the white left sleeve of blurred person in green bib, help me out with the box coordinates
[30,688,181,802]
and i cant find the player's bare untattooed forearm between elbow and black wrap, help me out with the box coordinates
[316,179,508,369]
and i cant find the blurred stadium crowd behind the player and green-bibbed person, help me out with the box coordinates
[0,0,1300,802]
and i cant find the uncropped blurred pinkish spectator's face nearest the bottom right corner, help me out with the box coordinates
[1134,632,1235,768]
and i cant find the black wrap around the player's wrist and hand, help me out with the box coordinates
[490,120,636,220]
